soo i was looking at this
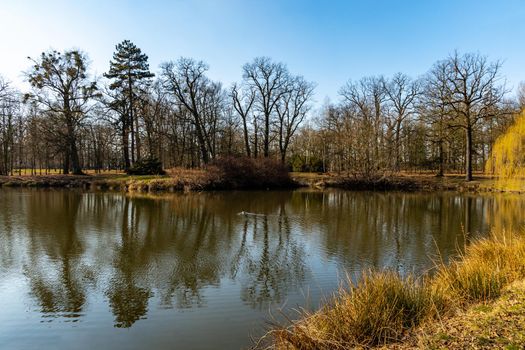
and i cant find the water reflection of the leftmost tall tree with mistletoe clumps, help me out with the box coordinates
[24,192,86,319]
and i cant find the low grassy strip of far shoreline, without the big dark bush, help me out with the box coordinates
[0,170,525,194]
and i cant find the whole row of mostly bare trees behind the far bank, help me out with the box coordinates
[0,40,525,179]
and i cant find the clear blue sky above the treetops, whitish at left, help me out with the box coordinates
[0,0,525,103]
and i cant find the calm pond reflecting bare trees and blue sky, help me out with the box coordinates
[0,189,525,349]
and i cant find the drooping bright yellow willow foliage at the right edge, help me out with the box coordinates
[485,112,525,191]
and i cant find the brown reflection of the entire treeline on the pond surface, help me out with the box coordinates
[0,191,525,328]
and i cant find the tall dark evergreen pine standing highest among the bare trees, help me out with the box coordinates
[104,40,154,169]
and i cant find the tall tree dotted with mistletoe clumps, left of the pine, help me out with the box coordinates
[25,50,98,174]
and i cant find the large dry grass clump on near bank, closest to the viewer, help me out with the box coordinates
[271,272,445,349]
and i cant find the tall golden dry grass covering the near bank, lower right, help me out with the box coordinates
[262,232,525,349]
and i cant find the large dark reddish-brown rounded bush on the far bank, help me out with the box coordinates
[209,157,293,189]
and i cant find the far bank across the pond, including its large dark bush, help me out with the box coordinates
[0,170,525,193]
